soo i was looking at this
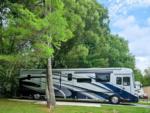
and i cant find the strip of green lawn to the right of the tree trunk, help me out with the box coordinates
[53,106,150,113]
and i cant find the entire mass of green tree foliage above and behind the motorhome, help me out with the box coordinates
[0,0,150,95]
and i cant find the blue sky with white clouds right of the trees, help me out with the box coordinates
[97,0,150,72]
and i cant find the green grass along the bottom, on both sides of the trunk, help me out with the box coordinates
[0,99,150,113]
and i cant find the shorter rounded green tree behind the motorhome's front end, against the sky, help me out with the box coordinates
[108,35,135,69]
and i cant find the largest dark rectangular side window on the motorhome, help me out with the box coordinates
[96,73,110,82]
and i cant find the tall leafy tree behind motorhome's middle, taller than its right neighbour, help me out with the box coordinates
[53,0,109,68]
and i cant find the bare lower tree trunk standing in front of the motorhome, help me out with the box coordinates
[46,58,56,109]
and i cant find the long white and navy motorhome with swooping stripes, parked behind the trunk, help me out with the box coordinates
[20,68,138,104]
